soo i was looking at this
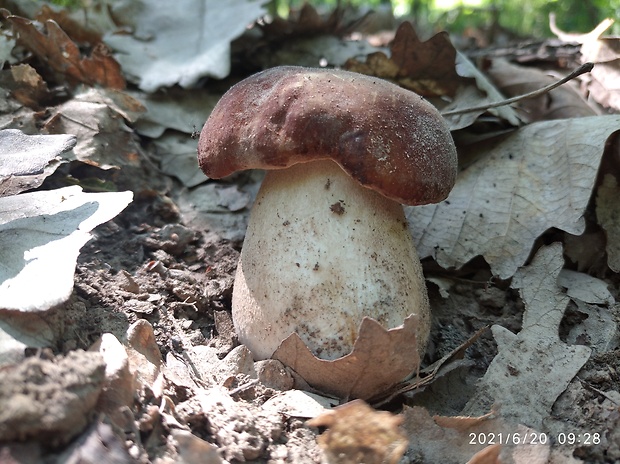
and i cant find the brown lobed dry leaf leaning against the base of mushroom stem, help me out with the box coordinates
[273,315,420,399]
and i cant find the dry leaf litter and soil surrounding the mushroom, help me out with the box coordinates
[0,0,620,463]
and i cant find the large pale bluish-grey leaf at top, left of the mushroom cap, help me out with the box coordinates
[105,0,264,92]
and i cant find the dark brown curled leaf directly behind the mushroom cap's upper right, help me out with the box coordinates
[345,21,462,97]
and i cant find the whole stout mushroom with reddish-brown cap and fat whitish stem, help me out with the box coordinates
[198,66,457,370]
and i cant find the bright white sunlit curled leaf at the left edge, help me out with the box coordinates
[0,186,132,311]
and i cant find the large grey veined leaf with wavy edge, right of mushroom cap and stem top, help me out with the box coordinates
[406,115,620,279]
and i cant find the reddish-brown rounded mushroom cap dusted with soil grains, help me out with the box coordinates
[198,66,457,205]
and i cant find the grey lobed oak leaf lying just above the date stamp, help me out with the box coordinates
[464,243,592,430]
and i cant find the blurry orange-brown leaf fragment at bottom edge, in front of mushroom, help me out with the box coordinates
[306,400,407,464]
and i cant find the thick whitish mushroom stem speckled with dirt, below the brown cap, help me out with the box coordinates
[232,160,430,359]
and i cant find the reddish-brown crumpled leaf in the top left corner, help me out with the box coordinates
[7,11,125,90]
